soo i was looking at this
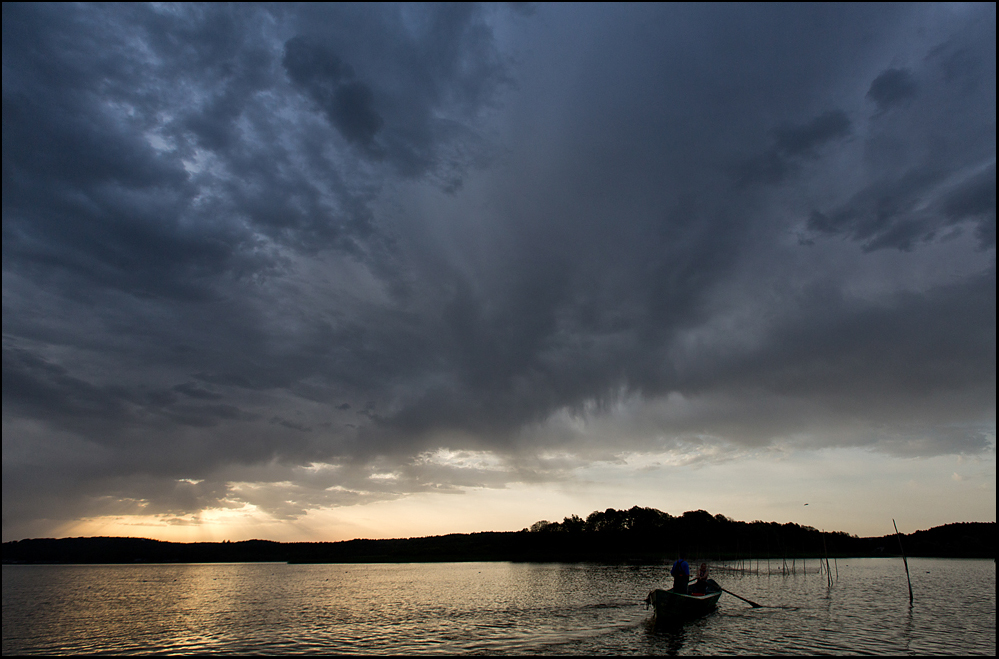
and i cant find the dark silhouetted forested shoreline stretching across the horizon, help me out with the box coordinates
[3,506,996,564]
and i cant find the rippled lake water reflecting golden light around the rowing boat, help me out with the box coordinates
[3,558,996,656]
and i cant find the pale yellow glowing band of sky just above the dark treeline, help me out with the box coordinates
[43,448,995,542]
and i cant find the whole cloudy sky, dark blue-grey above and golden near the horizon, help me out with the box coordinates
[2,3,996,541]
